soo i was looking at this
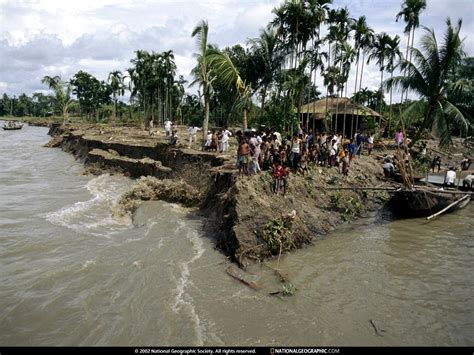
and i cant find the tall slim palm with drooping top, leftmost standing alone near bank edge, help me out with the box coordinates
[191,20,212,141]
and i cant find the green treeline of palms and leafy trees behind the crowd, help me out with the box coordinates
[1,0,473,146]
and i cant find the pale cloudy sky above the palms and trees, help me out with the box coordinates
[0,0,474,103]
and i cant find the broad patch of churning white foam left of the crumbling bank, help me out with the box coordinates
[45,174,131,237]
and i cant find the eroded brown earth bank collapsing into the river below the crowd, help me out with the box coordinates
[47,125,389,267]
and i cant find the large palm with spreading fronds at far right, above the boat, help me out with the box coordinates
[385,18,469,146]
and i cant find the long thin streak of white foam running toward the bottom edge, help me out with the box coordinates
[171,221,206,345]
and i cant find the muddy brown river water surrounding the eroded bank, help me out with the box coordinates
[0,127,474,345]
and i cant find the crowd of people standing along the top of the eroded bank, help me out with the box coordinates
[151,120,474,193]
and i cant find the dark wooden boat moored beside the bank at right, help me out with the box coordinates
[390,188,473,217]
